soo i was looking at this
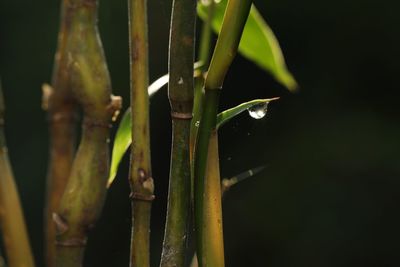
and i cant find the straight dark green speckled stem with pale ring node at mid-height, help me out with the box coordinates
[160,0,196,267]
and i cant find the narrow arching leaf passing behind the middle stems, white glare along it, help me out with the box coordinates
[107,62,203,187]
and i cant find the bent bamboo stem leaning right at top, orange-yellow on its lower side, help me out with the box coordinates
[194,0,252,267]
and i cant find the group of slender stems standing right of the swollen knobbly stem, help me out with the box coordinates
[129,0,251,267]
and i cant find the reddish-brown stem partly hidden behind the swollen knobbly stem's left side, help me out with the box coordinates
[42,0,77,267]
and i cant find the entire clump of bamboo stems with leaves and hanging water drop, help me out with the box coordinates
[0,0,296,267]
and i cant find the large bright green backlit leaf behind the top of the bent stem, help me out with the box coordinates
[197,0,297,91]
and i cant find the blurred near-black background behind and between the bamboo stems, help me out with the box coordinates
[0,0,400,267]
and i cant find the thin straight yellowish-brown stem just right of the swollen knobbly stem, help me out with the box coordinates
[128,0,154,267]
